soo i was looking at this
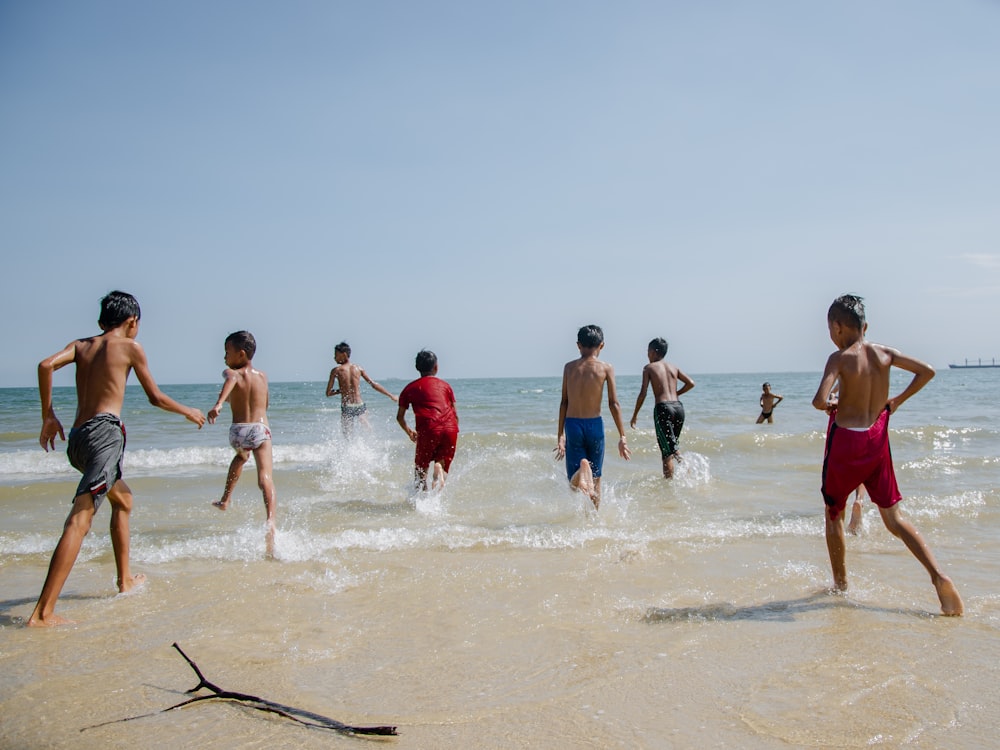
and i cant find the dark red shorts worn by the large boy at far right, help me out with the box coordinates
[822,409,903,518]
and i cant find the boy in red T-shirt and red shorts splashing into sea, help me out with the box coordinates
[396,349,458,490]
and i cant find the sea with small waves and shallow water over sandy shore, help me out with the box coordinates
[0,372,1000,750]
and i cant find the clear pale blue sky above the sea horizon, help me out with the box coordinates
[0,0,1000,387]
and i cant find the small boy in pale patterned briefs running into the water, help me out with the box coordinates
[208,331,276,557]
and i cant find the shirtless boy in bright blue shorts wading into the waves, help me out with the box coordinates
[555,325,632,510]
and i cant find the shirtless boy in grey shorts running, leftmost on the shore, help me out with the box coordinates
[27,291,205,626]
